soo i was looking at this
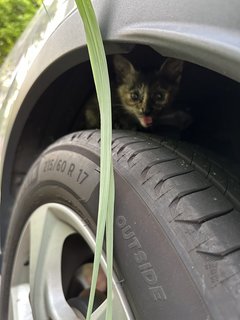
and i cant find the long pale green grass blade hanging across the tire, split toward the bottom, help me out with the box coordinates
[76,0,114,320]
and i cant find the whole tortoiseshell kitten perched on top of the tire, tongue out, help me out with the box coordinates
[82,55,183,130]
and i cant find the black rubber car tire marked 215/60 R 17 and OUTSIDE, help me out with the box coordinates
[0,131,240,320]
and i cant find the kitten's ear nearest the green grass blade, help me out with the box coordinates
[113,55,137,83]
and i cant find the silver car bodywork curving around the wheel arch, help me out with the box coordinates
[0,0,240,258]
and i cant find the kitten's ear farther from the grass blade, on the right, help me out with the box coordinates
[159,58,183,83]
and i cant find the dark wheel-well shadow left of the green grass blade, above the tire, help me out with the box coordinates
[11,63,93,194]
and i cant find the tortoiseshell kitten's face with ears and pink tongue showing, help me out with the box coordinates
[114,56,183,127]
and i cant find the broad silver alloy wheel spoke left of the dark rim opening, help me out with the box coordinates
[30,206,77,320]
